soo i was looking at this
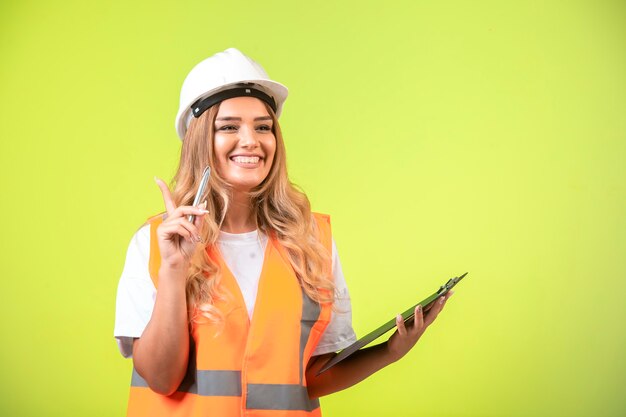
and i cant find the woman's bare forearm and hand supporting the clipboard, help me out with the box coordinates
[306,291,453,398]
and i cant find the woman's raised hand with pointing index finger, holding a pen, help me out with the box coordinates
[155,178,208,270]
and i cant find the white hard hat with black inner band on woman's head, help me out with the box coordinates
[175,48,288,140]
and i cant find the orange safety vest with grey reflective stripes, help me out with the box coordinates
[128,213,331,417]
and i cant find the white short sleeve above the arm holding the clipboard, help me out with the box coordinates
[313,239,356,356]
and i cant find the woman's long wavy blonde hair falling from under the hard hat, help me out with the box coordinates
[172,103,334,322]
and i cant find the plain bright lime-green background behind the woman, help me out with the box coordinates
[0,0,626,417]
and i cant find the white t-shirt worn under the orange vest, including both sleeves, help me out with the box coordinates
[114,225,356,358]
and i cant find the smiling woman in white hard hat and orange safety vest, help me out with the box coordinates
[115,48,451,416]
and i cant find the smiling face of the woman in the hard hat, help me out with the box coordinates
[213,97,276,192]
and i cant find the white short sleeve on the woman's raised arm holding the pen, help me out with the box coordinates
[113,225,156,358]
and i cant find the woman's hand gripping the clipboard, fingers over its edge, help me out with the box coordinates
[387,291,454,361]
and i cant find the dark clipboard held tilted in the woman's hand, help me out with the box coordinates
[317,272,467,375]
